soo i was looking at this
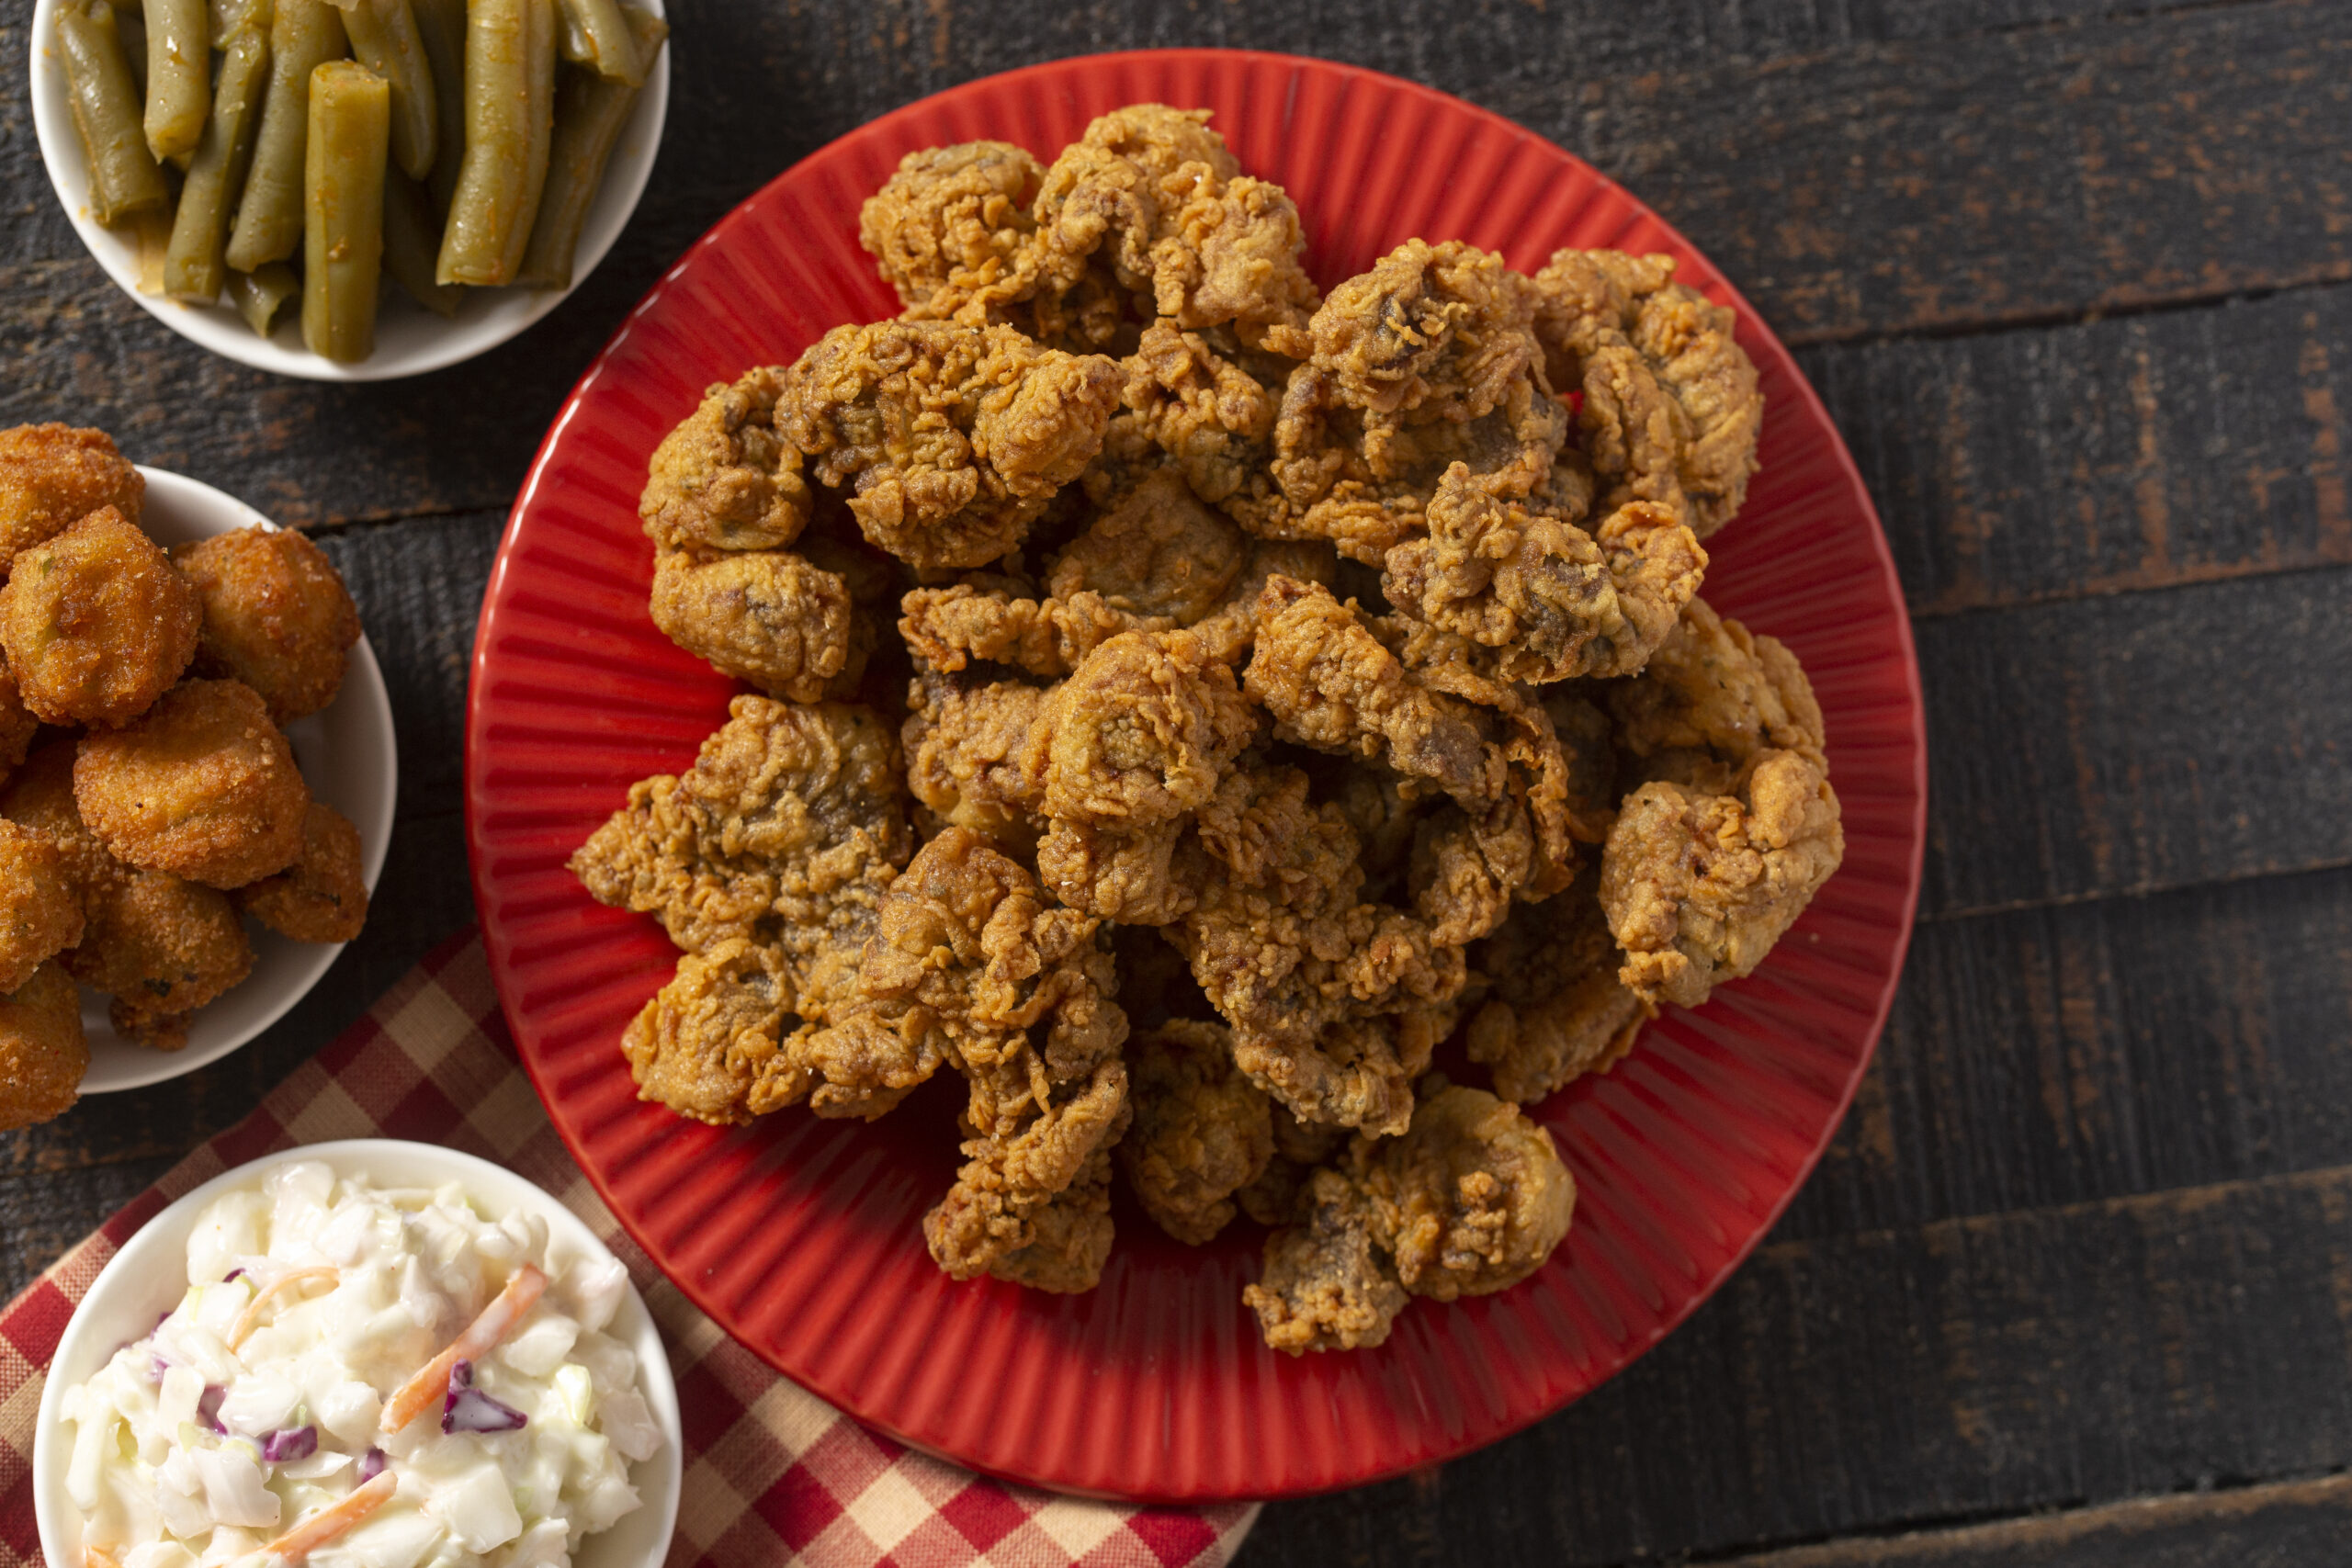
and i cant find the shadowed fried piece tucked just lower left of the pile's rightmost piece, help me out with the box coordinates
[1470,874,1658,1105]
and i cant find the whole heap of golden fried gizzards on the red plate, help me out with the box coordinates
[571,106,1844,1352]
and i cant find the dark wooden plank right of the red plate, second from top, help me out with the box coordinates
[1799,289,2352,616]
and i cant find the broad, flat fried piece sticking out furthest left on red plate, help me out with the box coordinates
[571,696,912,1021]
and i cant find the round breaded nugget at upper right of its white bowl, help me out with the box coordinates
[172,525,360,724]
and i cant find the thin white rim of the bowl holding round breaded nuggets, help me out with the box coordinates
[83,463,400,1096]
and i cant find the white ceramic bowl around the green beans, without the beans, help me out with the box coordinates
[33,0,677,381]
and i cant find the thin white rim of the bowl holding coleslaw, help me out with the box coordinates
[30,1138,684,1568]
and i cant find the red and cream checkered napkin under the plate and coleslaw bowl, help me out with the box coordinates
[0,936,1259,1568]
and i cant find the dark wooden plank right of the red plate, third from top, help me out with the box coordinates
[1917,569,2352,917]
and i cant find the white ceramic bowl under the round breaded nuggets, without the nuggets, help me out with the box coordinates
[83,468,400,1096]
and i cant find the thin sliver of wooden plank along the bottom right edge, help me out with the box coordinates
[1719,1476,2352,1568]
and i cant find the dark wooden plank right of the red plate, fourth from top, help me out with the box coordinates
[1778,870,2352,1239]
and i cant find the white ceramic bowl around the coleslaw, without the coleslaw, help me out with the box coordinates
[33,1138,684,1568]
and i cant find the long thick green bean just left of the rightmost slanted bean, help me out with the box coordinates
[433,0,555,287]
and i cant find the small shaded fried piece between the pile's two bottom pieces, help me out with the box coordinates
[1117,1018,1275,1246]
